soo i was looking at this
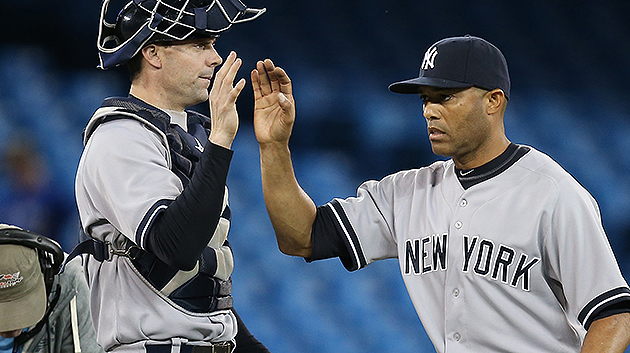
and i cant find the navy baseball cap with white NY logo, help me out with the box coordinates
[389,35,511,99]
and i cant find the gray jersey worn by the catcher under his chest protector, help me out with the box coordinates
[76,100,237,352]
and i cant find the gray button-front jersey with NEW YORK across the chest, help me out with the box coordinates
[309,144,630,352]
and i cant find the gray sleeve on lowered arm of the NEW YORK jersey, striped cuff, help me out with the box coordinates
[545,178,630,330]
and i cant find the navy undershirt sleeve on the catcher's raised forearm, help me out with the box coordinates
[146,142,233,271]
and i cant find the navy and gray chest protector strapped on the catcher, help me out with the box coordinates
[72,97,233,313]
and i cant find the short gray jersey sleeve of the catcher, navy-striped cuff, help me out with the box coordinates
[77,119,183,246]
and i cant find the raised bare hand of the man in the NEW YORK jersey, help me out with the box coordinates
[251,59,295,144]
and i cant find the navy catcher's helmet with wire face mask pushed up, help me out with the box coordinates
[97,0,266,70]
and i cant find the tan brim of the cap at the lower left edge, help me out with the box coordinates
[0,278,47,332]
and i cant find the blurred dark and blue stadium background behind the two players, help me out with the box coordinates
[0,0,630,353]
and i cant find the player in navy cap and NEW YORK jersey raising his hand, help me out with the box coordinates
[251,36,630,352]
